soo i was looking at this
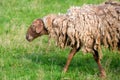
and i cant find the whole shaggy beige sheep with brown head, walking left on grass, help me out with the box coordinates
[26,2,120,77]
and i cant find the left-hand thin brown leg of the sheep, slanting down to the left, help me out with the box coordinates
[63,47,79,72]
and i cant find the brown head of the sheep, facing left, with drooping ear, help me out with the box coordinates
[26,19,48,41]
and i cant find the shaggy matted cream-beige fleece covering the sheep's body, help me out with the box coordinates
[43,3,120,52]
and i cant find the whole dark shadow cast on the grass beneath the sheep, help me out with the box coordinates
[20,51,120,75]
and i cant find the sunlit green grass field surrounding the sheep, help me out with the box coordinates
[0,0,120,80]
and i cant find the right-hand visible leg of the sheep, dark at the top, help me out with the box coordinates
[93,50,106,78]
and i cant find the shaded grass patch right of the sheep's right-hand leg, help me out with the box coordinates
[102,53,120,77]
